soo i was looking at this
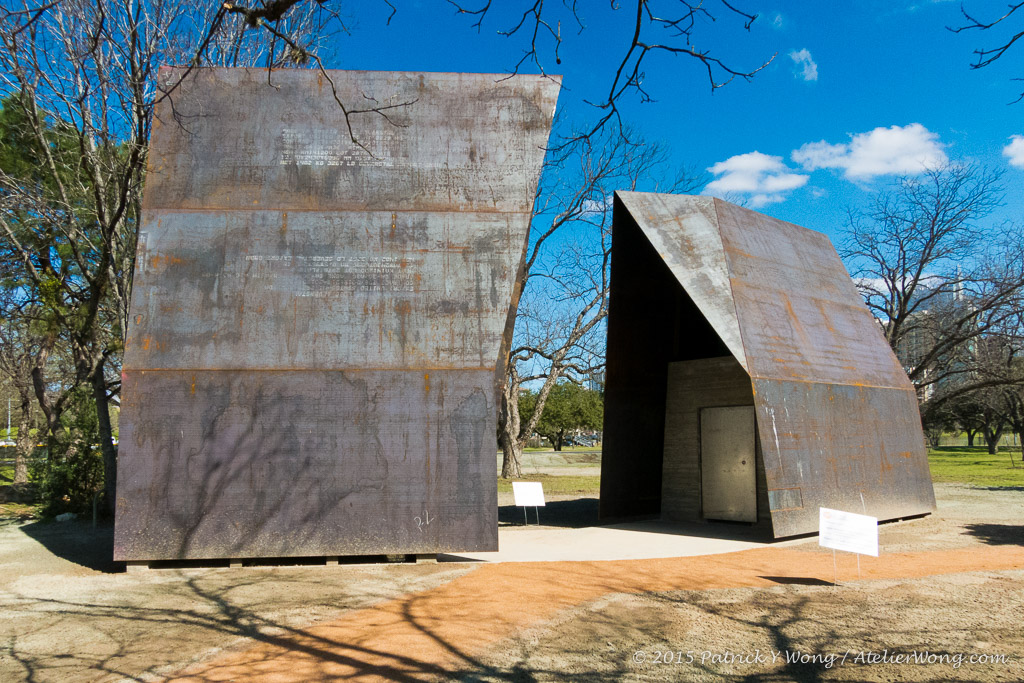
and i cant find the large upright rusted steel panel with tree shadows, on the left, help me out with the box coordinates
[115,69,558,560]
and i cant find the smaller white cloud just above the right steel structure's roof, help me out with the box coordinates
[705,152,809,208]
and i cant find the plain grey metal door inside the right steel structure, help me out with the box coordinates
[700,405,758,522]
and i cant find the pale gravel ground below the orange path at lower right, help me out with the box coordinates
[477,571,1024,681]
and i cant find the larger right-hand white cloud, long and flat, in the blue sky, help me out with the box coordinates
[791,123,942,180]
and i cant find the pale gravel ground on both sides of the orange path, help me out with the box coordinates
[0,484,1024,681]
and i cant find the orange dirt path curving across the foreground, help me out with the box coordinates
[168,546,1024,682]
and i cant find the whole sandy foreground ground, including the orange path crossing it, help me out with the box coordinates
[0,484,1024,681]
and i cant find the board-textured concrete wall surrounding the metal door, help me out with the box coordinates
[662,355,771,535]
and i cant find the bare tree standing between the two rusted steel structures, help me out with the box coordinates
[498,130,701,478]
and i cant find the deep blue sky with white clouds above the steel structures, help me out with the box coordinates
[331,0,1024,245]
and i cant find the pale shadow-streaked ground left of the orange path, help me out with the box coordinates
[0,522,470,682]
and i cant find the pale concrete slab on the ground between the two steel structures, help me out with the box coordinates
[437,521,790,562]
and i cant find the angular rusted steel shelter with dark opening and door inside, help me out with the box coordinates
[601,193,935,538]
